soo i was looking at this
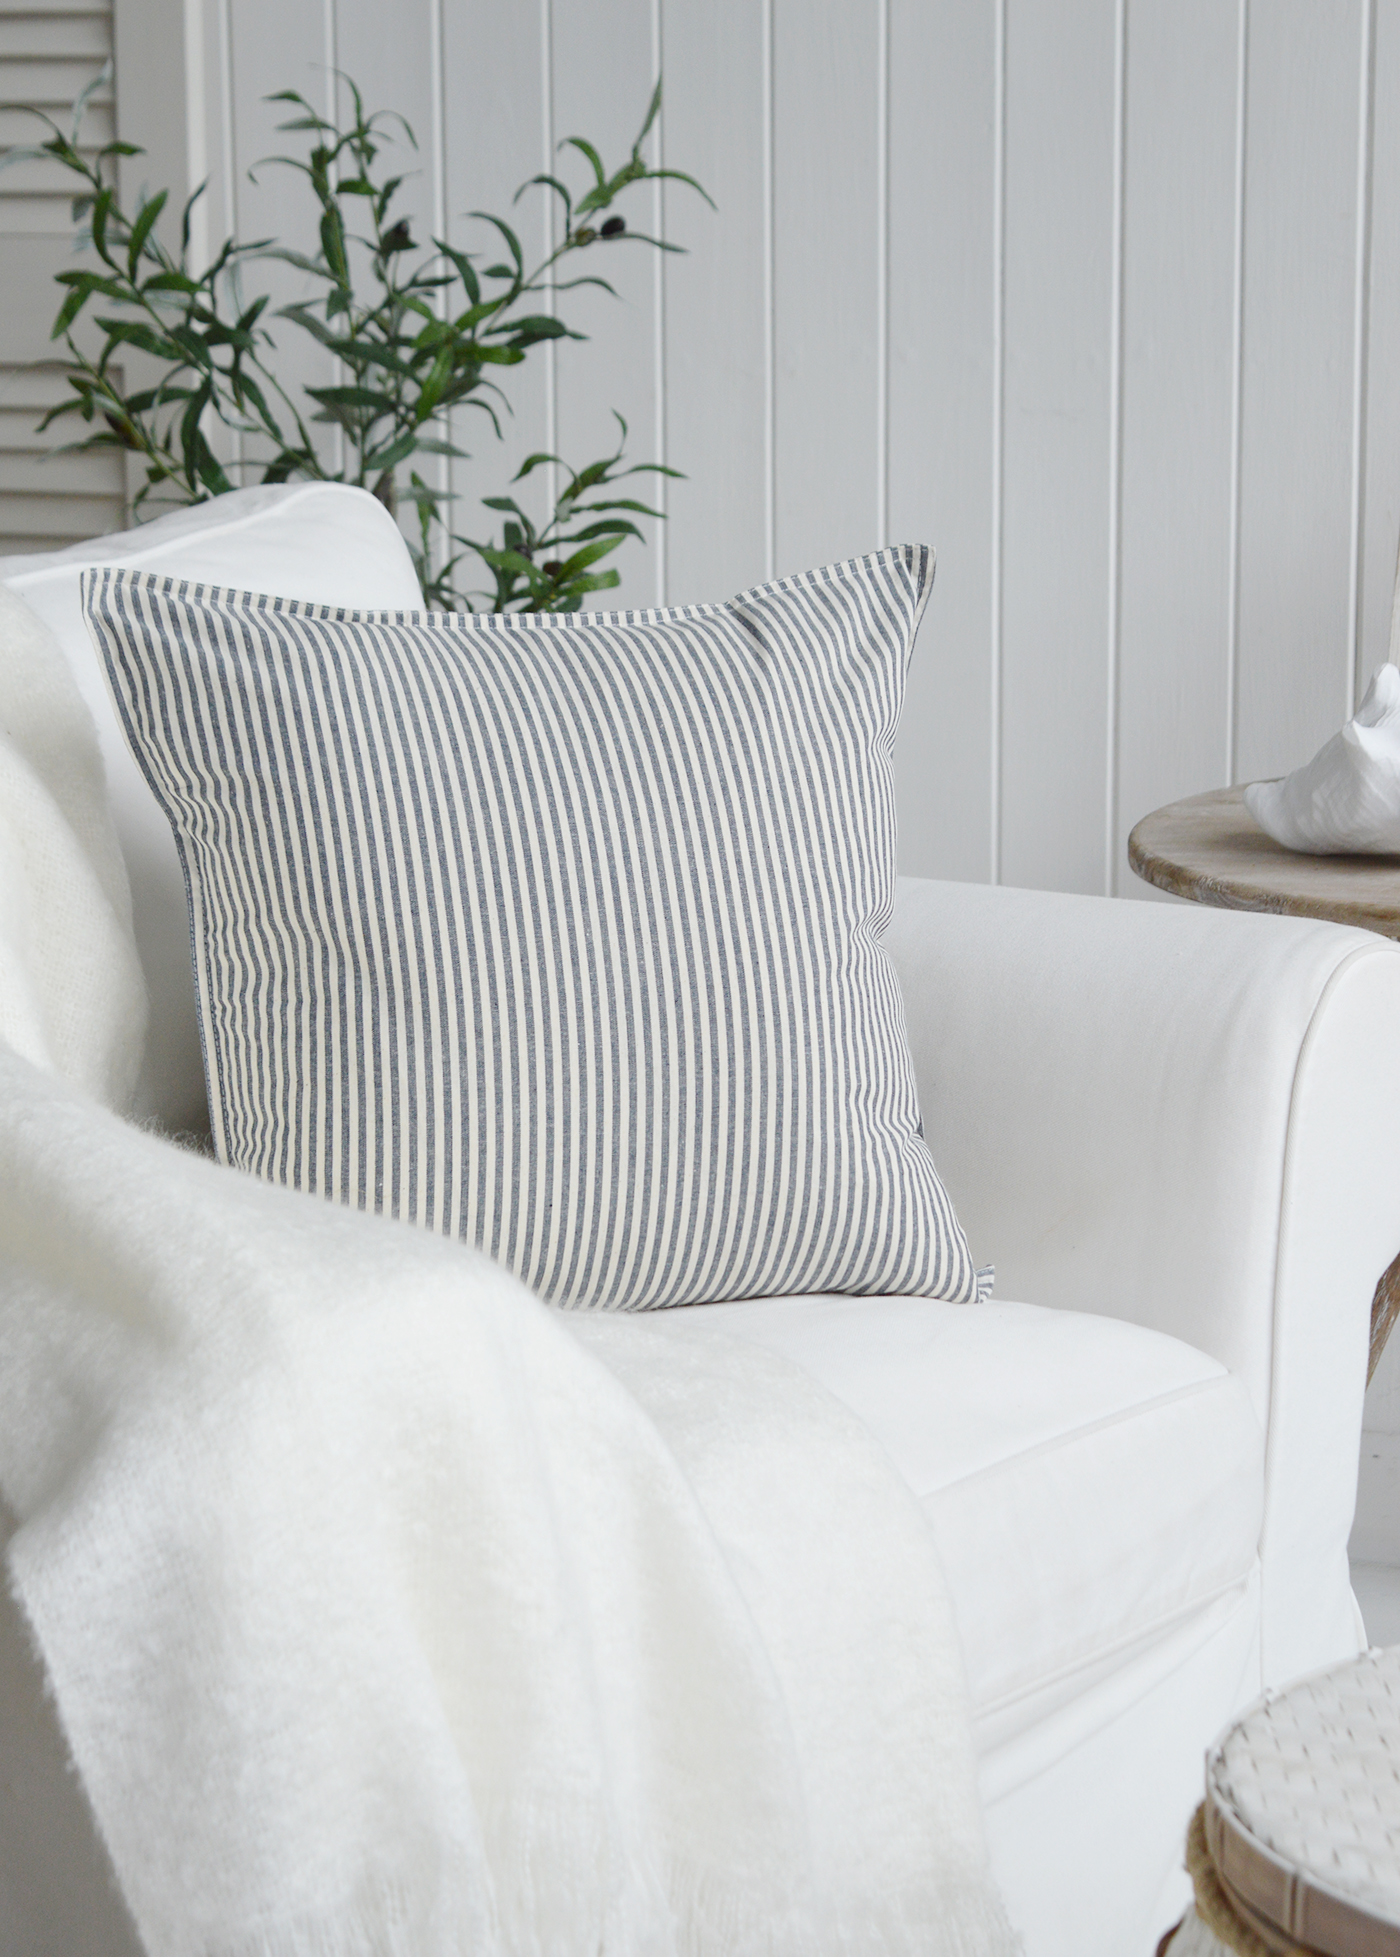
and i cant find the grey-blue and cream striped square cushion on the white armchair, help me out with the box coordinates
[84,548,977,1307]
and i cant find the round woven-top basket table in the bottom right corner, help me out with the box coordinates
[1161,1646,1400,1957]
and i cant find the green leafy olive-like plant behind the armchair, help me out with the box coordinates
[12,76,709,611]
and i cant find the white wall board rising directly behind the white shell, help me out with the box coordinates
[1236,0,1365,781]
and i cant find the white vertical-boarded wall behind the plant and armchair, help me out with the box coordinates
[24,0,1400,896]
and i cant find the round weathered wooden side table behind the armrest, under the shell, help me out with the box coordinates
[1128,787,1400,1380]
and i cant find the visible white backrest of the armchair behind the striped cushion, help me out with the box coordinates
[0,483,421,1129]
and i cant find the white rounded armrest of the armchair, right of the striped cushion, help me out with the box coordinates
[885,879,1400,1679]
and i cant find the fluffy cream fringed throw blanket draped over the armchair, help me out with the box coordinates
[0,591,1014,1957]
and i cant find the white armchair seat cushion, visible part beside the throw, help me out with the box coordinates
[683,1297,1265,1748]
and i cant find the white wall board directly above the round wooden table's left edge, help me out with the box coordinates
[1114,0,1239,894]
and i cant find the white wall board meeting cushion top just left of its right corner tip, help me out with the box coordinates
[773,0,887,573]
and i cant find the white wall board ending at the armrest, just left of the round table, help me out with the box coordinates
[1001,0,1116,890]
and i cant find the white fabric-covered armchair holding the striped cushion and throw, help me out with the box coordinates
[0,487,1400,1957]
